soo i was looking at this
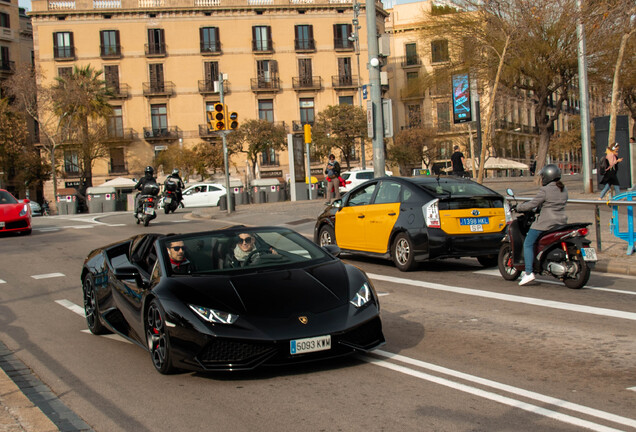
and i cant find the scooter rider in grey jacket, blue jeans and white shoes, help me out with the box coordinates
[517,164,568,285]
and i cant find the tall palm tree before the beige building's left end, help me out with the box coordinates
[53,65,113,195]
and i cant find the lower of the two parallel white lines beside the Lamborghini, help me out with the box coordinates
[360,356,636,432]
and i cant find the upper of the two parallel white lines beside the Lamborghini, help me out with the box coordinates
[371,350,636,428]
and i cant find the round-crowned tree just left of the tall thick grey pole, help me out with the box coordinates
[312,104,367,169]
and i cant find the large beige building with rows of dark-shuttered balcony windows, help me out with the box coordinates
[30,0,386,192]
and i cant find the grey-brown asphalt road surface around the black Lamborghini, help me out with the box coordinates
[0,210,636,432]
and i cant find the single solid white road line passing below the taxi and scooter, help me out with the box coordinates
[367,273,636,321]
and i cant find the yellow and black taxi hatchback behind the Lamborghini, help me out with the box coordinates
[314,176,510,271]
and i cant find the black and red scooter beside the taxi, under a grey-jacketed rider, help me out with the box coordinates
[497,189,597,289]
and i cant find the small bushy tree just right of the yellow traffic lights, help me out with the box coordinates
[227,119,287,178]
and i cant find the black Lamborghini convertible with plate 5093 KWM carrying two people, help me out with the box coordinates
[82,227,384,373]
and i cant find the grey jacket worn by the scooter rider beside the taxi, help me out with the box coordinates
[517,182,568,231]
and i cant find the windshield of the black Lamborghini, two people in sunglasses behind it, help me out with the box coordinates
[159,227,333,275]
